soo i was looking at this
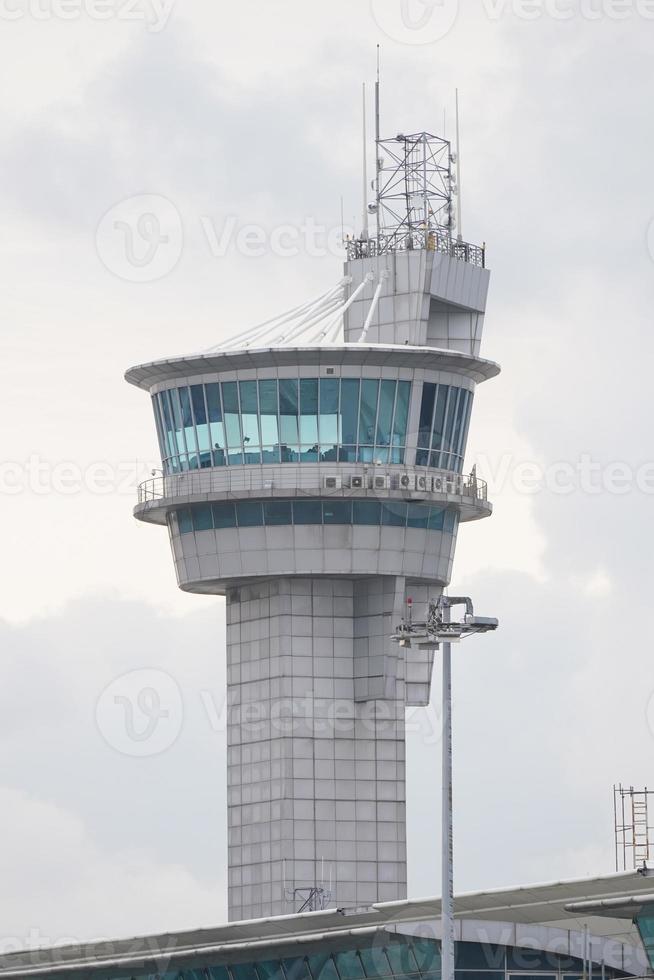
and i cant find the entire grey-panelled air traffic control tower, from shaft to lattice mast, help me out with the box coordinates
[127,133,499,920]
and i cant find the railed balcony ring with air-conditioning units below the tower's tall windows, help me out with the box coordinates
[138,464,488,504]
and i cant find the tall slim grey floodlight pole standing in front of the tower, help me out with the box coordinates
[393,596,498,980]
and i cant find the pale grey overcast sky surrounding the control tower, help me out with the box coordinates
[0,0,654,948]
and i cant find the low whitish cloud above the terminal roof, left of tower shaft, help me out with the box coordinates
[0,786,225,952]
